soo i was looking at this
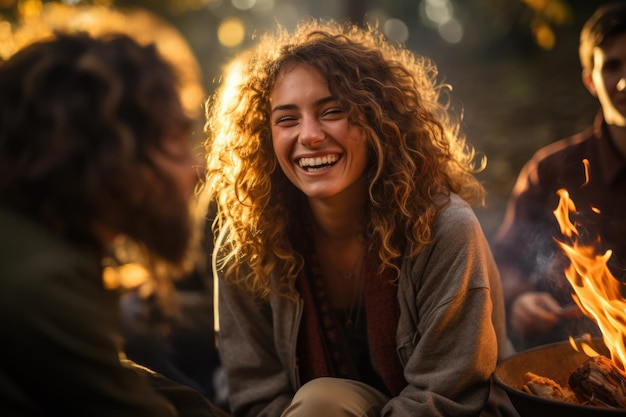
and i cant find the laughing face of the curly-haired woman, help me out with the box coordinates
[270,64,367,199]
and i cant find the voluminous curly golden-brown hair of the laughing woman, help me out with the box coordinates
[205,20,485,298]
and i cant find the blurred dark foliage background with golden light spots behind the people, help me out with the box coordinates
[0,0,624,238]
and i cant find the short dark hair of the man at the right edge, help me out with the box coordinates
[578,1,626,71]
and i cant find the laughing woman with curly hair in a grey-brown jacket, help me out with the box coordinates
[205,17,510,417]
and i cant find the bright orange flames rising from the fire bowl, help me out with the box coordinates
[553,189,626,371]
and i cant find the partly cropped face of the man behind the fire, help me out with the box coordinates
[583,33,626,127]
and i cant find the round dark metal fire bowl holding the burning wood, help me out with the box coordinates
[494,339,626,417]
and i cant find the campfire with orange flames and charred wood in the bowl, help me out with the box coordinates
[522,180,626,409]
